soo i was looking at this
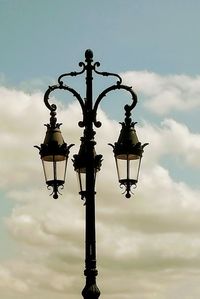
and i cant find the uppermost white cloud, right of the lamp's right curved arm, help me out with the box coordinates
[122,71,200,115]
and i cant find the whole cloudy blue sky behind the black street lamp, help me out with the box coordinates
[0,0,200,299]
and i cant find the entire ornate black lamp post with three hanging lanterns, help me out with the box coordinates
[36,49,147,299]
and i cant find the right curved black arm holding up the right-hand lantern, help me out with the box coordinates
[93,84,137,127]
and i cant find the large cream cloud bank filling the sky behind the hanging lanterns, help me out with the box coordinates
[0,85,200,299]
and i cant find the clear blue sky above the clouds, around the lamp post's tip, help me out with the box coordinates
[0,0,200,84]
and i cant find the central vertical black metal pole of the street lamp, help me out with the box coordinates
[82,50,100,299]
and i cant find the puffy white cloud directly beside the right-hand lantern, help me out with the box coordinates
[140,118,200,169]
